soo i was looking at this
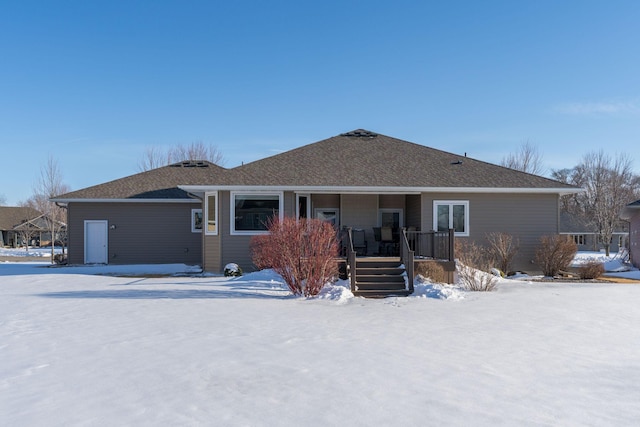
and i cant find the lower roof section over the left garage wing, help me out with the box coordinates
[52,161,226,202]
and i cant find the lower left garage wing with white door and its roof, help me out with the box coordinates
[53,161,224,264]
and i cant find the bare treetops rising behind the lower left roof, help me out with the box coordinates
[138,141,225,172]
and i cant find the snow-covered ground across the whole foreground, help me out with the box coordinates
[0,254,640,426]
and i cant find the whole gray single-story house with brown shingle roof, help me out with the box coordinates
[52,129,580,280]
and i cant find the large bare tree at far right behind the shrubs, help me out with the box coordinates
[552,150,640,255]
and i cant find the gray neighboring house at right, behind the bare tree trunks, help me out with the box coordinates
[560,212,629,253]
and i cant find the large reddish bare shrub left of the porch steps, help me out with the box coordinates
[251,217,338,297]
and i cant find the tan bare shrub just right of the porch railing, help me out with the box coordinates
[456,240,498,292]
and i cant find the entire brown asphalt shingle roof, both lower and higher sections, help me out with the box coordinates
[54,129,576,200]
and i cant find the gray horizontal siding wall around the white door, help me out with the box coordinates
[68,203,202,265]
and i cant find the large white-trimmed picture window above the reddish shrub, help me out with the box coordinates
[231,192,284,234]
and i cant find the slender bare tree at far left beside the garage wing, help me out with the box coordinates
[28,155,70,262]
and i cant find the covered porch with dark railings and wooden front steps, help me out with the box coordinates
[295,193,455,296]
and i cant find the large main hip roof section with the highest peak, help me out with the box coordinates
[189,129,579,193]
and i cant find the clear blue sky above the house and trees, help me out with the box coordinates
[0,0,640,204]
